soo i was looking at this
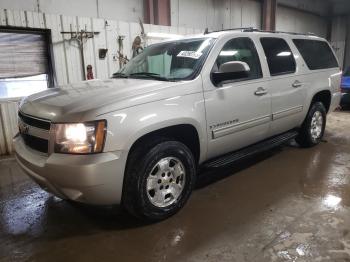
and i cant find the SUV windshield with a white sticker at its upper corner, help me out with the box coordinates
[113,38,213,81]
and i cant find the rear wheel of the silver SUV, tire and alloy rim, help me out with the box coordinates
[295,102,327,147]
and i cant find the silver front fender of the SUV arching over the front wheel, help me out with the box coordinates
[100,93,207,162]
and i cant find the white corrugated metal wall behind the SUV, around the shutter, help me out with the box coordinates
[0,9,204,155]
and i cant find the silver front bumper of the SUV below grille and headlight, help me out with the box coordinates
[13,136,127,205]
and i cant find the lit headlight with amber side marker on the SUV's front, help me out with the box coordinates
[54,120,107,154]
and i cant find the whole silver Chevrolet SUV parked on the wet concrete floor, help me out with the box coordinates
[14,29,341,220]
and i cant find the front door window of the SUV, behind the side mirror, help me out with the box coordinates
[213,37,262,80]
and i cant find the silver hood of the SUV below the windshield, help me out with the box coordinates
[20,79,189,122]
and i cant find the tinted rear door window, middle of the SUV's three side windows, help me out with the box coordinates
[260,37,295,76]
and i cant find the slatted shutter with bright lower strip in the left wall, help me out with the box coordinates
[0,29,49,99]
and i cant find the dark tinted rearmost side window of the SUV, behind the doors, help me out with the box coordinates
[293,39,338,70]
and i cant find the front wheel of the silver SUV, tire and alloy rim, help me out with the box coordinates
[122,139,196,222]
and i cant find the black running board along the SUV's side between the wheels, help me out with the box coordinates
[202,130,298,168]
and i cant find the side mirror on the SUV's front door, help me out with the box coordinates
[211,61,250,85]
